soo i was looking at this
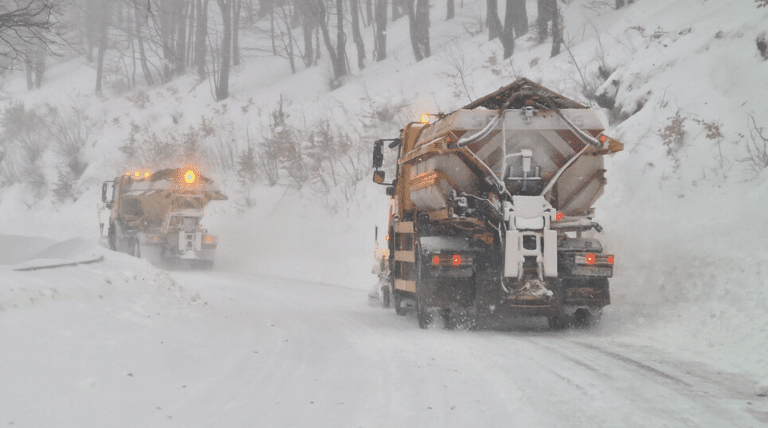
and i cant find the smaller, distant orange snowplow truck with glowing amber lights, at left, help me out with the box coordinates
[101,168,227,268]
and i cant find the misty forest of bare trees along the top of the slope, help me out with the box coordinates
[0,0,584,101]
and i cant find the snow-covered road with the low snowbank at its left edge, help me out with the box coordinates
[0,253,768,428]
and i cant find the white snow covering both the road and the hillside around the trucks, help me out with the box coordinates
[0,0,768,427]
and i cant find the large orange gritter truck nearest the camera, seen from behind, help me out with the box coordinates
[373,78,623,329]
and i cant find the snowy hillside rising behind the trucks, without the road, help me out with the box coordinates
[0,0,768,422]
